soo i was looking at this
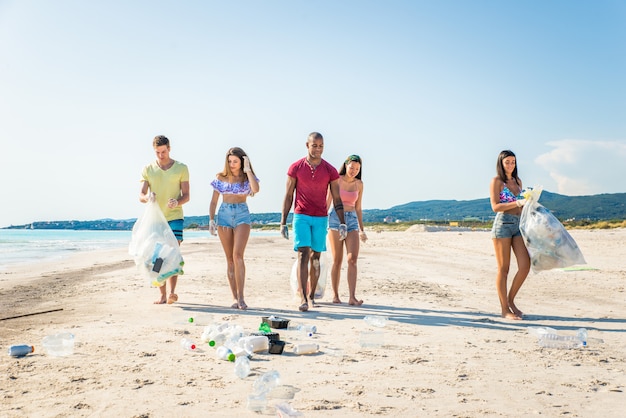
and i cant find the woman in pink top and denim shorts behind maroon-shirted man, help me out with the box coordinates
[326,155,367,305]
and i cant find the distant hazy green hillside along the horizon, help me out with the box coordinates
[7,191,626,230]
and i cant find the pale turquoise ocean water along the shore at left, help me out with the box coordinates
[0,229,279,271]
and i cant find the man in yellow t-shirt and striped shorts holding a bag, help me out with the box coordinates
[139,135,189,304]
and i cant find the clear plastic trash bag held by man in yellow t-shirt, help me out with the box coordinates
[128,202,184,287]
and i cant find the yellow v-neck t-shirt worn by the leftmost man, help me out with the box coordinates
[141,161,189,221]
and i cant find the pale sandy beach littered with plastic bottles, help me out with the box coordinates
[0,229,626,418]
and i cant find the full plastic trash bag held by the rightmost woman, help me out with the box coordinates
[520,187,586,273]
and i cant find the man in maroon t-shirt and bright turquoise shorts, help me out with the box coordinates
[280,132,348,312]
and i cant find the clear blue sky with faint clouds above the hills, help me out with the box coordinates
[0,0,626,226]
